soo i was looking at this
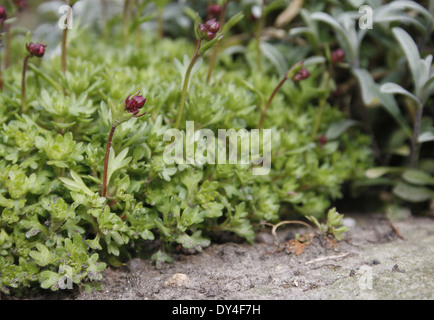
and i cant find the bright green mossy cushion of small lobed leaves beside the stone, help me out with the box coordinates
[0,0,380,293]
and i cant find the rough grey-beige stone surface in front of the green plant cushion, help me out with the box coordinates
[75,216,434,300]
